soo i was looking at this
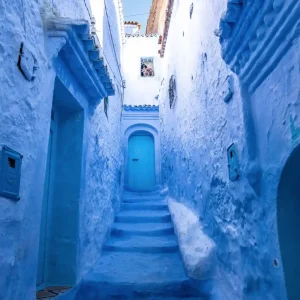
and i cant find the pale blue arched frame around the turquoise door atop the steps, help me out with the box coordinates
[123,123,161,191]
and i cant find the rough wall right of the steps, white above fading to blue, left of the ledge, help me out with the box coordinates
[160,1,246,299]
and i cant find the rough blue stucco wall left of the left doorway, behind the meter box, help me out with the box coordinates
[0,1,55,300]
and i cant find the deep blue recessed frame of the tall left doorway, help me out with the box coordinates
[36,75,87,291]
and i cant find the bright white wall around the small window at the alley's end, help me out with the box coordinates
[123,36,163,105]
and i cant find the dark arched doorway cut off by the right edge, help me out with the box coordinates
[277,146,300,300]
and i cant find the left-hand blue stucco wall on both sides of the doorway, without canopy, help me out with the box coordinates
[0,0,122,300]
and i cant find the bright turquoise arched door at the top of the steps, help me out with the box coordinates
[128,131,155,191]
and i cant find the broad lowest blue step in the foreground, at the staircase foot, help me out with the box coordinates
[59,252,208,300]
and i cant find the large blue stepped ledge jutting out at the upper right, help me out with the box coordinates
[216,0,300,92]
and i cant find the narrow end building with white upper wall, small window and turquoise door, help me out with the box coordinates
[122,22,162,196]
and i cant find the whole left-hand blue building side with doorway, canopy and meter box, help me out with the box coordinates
[0,1,124,300]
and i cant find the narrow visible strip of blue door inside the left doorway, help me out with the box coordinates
[36,111,56,286]
